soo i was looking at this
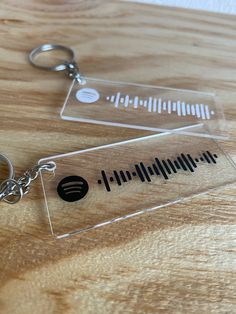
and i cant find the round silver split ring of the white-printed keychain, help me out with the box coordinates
[29,44,75,71]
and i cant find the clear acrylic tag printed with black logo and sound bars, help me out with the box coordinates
[40,125,236,237]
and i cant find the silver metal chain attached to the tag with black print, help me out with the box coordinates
[0,161,56,204]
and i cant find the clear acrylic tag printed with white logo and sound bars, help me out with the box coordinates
[61,78,227,138]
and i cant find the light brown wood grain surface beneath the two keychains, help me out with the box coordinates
[0,0,236,314]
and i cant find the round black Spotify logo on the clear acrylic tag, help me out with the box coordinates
[57,176,89,202]
